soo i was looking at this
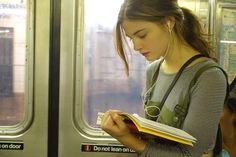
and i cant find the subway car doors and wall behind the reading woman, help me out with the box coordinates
[0,0,236,157]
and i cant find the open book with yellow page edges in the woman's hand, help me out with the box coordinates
[97,112,196,146]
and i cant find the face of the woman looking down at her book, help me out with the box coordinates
[122,20,170,61]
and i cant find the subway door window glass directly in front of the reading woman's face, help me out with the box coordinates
[83,0,146,127]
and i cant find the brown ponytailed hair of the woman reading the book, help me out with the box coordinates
[115,0,213,75]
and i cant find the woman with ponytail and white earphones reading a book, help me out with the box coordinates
[101,0,226,157]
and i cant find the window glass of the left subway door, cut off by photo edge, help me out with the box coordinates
[0,0,26,126]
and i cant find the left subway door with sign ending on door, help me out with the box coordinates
[0,0,50,157]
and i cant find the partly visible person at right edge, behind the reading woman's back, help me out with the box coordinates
[220,78,236,157]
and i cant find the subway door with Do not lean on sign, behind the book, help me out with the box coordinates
[58,0,147,157]
